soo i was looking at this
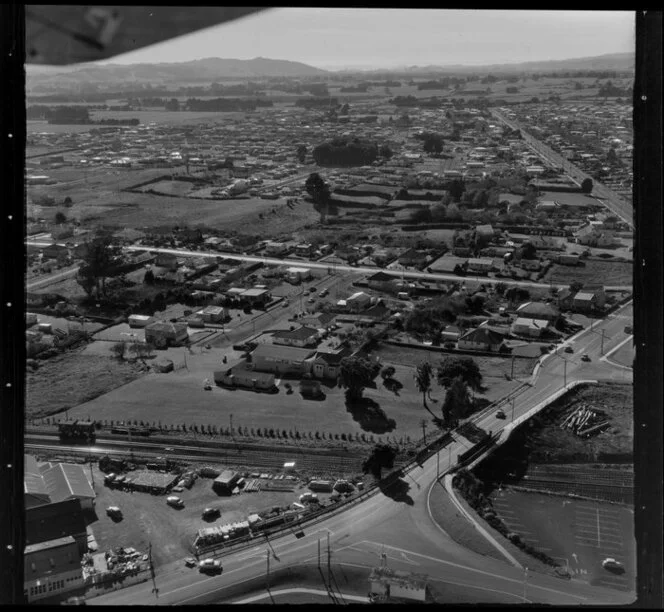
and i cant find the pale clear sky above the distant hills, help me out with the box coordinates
[104,7,635,70]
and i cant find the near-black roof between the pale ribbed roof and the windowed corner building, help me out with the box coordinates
[25,498,85,544]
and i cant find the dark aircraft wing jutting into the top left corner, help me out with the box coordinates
[25,4,265,65]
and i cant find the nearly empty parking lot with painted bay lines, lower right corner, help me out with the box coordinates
[491,489,636,591]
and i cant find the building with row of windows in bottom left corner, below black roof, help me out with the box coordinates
[23,535,84,603]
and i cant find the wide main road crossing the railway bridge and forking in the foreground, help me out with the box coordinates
[88,303,634,605]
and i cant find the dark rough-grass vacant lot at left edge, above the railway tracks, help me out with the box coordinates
[25,350,141,418]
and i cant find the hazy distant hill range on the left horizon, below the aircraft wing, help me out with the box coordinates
[27,57,328,86]
